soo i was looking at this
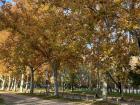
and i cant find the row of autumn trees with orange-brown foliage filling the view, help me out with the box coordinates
[0,0,140,99]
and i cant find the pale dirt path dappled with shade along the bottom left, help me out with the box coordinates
[1,93,89,105]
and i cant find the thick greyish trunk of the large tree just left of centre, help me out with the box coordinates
[52,62,59,96]
